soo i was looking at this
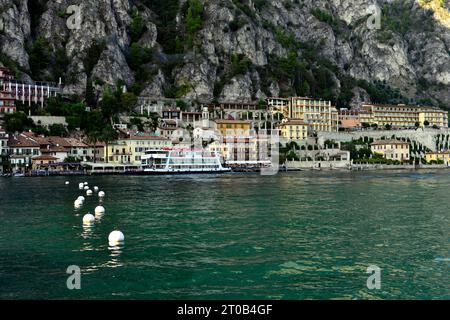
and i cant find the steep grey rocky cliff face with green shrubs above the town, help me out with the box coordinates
[0,0,450,107]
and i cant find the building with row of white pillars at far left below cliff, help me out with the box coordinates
[0,68,62,107]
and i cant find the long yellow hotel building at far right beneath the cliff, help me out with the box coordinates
[359,104,448,128]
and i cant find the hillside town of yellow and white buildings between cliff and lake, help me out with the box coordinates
[0,68,450,176]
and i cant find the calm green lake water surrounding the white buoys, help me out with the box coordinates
[0,172,450,299]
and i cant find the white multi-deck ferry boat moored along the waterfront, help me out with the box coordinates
[141,149,231,174]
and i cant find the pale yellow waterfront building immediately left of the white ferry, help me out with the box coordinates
[105,136,172,165]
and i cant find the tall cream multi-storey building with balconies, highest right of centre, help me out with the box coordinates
[266,97,339,132]
